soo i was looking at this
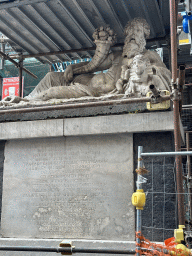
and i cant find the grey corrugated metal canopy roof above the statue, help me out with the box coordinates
[0,0,170,63]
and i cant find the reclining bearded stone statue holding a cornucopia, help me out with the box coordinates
[2,18,171,102]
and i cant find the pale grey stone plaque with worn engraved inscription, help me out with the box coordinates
[1,134,135,240]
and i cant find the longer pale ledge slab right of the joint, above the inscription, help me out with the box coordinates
[64,111,174,136]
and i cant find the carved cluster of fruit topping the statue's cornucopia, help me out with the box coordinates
[93,26,117,45]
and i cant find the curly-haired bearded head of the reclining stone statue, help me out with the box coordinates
[123,18,150,58]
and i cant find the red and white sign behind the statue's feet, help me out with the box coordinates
[2,77,24,99]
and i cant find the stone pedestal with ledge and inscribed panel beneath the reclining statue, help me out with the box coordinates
[0,111,182,256]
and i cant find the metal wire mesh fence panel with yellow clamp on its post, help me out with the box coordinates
[132,146,192,256]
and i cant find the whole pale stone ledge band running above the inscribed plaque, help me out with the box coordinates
[0,111,174,140]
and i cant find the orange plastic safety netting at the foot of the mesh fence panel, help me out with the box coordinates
[136,232,189,256]
